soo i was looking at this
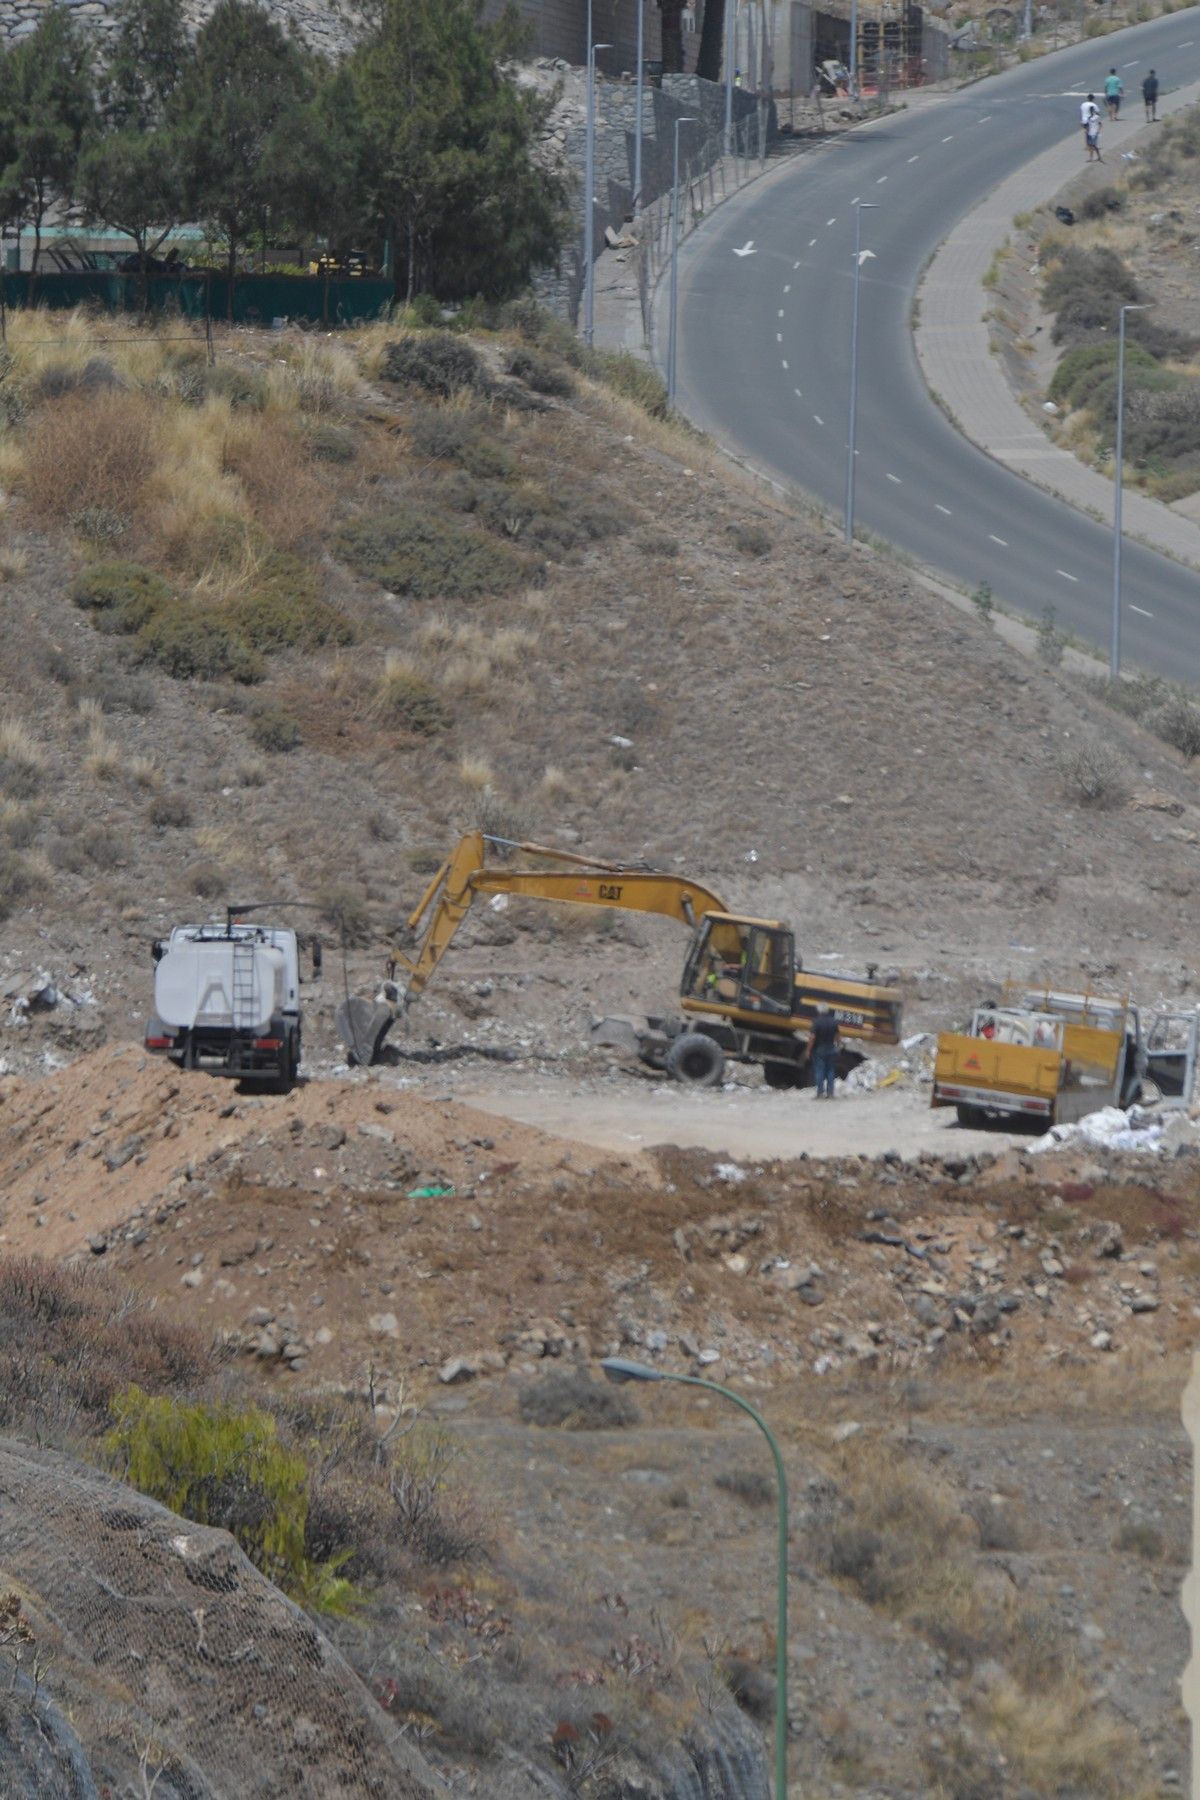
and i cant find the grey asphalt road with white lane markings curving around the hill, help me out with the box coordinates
[672,9,1200,680]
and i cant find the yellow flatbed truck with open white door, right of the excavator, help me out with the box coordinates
[930,988,1196,1125]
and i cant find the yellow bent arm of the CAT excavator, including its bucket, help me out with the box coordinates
[338,832,725,1064]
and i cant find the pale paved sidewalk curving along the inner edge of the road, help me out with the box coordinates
[916,83,1200,567]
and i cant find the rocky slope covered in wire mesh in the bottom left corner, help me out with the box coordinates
[0,1438,444,1800]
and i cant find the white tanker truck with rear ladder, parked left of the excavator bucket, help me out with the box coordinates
[146,918,300,1093]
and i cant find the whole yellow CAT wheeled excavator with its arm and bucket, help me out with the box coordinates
[336,832,901,1087]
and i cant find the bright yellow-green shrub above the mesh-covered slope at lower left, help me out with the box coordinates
[103,1386,356,1613]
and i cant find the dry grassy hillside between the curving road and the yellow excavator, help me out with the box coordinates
[0,313,1196,1067]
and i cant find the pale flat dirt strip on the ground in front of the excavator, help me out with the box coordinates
[455,1082,1025,1159]
